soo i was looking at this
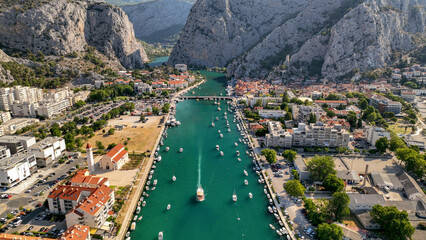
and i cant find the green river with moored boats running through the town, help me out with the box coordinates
[131,72,279,240]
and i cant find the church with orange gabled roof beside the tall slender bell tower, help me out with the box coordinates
[99,144,129,170]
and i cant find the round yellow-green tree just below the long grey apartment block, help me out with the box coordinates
[307,156,336,181]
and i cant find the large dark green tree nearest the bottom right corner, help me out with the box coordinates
[370,205,414,240]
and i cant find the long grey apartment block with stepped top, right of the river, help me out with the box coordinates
[293,122,350,147]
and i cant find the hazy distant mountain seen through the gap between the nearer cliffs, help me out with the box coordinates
[121,0,193,43]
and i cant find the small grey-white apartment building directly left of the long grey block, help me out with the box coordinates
[265,121,293,148]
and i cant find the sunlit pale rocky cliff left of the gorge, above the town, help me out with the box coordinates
[0,0,148,68]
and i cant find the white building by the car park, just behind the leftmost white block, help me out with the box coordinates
[28,137,66,167]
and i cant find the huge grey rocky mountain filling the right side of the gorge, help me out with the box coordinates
[169,0,426,79]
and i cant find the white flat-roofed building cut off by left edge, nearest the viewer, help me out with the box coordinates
[0,153,37,187]
